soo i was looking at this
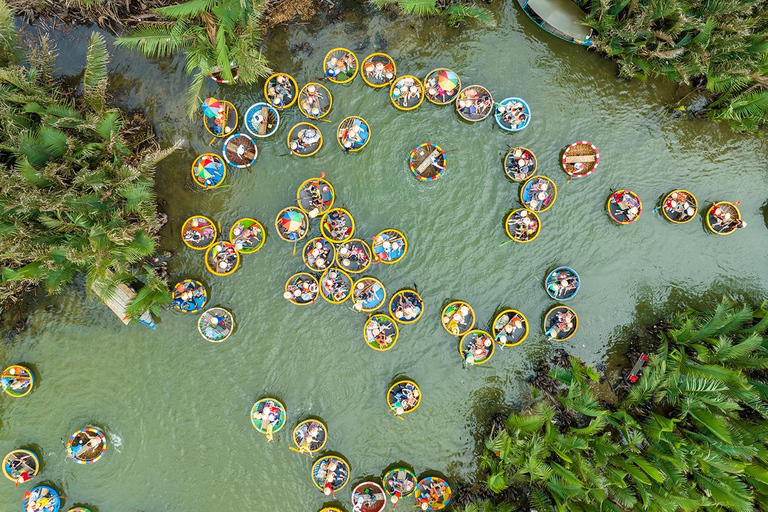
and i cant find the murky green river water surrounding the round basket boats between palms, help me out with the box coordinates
[0,2,768,512]
